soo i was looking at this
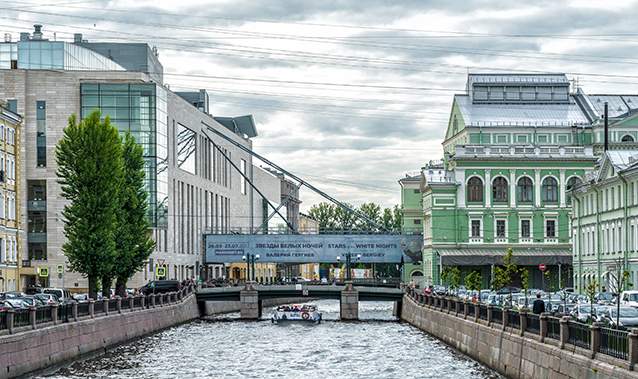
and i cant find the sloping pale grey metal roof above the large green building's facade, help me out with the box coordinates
[455,95,589,126]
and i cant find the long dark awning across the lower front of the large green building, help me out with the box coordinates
[435,248,572,266]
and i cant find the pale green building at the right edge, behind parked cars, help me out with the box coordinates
[572,151,638,293]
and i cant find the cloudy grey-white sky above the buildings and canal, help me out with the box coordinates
[0,0,638,209]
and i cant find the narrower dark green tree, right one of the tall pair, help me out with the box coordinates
[113,133,155,297]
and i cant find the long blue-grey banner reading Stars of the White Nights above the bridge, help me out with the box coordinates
[205,234,423,263]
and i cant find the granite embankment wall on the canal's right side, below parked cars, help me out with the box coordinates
[401,295,638,379]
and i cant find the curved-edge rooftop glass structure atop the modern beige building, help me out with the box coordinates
[16,41,124,71]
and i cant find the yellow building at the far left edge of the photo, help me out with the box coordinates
[0,103,24,292]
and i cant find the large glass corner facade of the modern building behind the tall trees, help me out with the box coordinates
[80,83,168,227]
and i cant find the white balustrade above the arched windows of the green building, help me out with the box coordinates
[456,145,594,159]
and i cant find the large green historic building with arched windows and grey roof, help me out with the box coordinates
[400,74,620,287]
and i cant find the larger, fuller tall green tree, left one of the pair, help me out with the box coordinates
[55,111,122,299]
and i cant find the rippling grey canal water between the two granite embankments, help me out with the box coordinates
[42,300,500,379]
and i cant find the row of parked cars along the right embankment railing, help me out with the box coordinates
[431,286,638,329]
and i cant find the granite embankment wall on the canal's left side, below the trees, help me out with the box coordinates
[0,294,199,378]
